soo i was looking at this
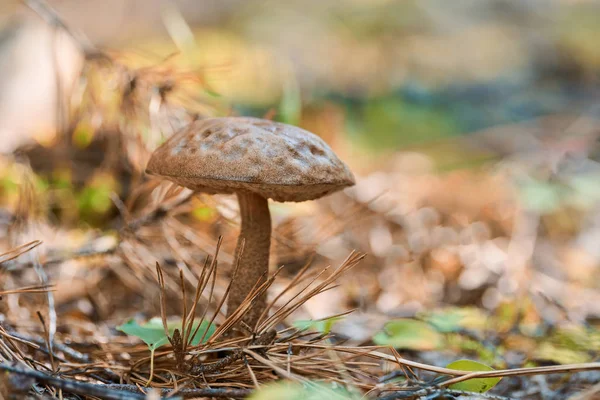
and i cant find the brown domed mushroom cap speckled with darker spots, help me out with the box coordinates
[146,117,354,201]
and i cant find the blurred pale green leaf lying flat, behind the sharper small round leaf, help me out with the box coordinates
[373,319,444,350]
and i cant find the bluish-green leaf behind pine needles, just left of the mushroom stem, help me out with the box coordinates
[117,317,216,350]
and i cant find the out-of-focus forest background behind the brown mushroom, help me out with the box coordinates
[0,0,600,357]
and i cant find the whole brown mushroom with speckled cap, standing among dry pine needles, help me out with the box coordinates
[146,117,354,329]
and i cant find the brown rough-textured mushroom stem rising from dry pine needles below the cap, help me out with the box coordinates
[227,192,271,329]
